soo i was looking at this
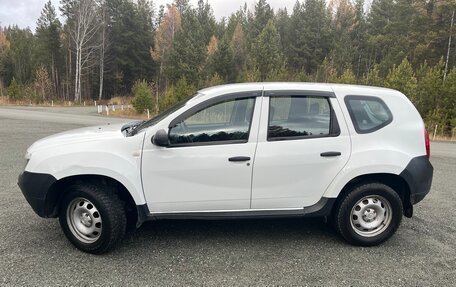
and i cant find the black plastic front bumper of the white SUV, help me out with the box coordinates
[17,171,57,217]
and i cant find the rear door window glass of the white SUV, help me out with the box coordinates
[268,96,331,139]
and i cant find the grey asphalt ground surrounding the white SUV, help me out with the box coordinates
[0,108,456,286]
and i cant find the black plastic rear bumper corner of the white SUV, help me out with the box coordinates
[400,156,434,205]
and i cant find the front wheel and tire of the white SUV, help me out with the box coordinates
[59,184,127,254]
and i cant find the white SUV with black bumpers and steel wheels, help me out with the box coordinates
[19,83,433,253]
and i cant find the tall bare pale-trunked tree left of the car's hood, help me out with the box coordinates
[68,0,100,102]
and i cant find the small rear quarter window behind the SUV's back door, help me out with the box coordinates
[345,96,393,134]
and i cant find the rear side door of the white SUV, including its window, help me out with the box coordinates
[251,91,351,209]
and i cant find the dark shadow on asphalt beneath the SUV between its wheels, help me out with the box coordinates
[121,218,341,254]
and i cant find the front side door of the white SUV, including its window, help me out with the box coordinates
[142,93,261,213]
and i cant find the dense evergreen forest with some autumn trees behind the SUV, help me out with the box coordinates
[0,0,456,136]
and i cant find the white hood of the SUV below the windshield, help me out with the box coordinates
[27,124,124,154]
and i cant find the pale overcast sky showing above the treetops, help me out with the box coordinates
[0,0,296,31]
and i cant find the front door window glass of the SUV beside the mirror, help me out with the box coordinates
[169,98,255,144]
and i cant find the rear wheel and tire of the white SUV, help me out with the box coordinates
[334,182,403,246]
